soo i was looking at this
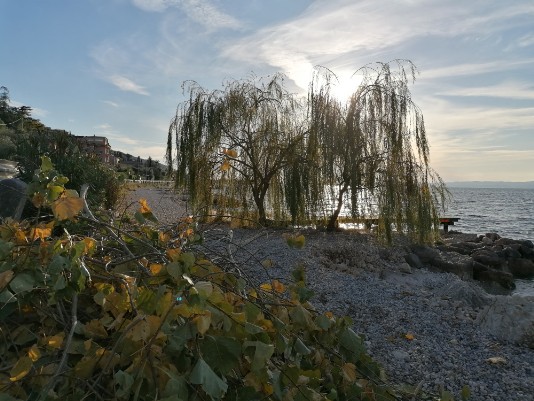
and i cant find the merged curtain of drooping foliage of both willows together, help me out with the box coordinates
[167,61,446,241]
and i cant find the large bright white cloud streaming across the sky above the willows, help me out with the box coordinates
[224,0,534,90]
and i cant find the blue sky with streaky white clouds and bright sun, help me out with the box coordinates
[0,0,534,181]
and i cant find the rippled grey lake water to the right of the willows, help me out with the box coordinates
[445,188,534,295]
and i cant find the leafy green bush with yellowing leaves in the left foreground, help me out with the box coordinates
[0,158,468,401]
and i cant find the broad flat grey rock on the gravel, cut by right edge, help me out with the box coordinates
[476,295,534,349]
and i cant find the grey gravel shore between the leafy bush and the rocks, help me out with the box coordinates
[123,188,534,401]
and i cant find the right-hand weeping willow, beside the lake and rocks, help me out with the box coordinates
[308,61,445,241]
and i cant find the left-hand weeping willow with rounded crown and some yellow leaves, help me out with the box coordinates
[167,74,305,224]
